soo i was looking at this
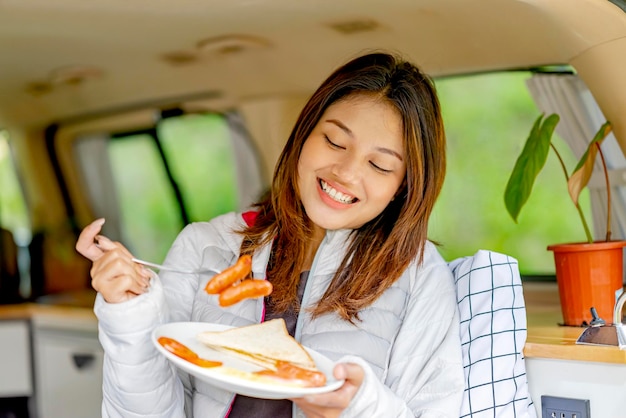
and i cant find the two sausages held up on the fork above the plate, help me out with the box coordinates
[204,254,273,307]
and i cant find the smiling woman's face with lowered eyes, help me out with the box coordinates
[298,95,406,230]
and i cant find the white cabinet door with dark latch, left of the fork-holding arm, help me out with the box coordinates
[33,328,103,418]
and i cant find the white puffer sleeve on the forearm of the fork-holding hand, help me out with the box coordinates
[94,276,185,418]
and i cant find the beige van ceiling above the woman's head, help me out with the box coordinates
[0,0,626,127]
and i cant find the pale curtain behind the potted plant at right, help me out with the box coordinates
[527,74,626,240]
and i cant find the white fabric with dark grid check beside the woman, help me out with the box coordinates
[449,250,537,418]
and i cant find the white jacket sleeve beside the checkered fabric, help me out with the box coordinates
[341,263,464,418]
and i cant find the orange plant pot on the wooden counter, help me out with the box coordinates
[548,241,626,326]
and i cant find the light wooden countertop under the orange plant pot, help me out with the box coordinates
[524,282,626,365]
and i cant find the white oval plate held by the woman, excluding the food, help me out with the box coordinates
[152,322,344,399]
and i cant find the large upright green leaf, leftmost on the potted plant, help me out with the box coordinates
[504,114,559,222]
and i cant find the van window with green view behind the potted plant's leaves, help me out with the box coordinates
[429,72,591,276]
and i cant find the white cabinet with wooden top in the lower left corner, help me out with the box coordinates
[0,304,104,418]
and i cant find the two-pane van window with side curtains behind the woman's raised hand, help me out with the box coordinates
[74,109,264,262]
